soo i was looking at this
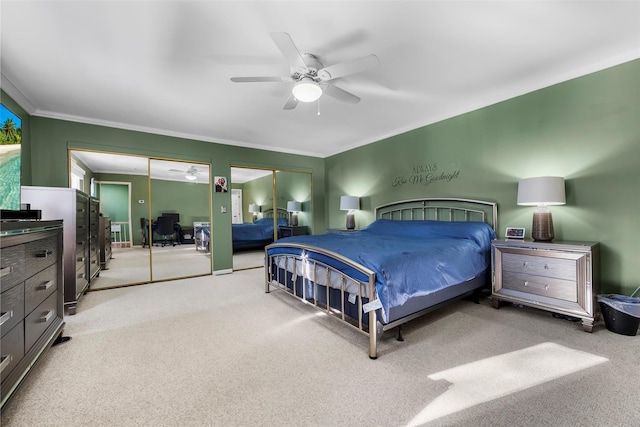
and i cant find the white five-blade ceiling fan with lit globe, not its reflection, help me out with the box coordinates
[231,33,380,110]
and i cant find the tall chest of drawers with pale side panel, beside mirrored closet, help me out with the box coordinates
[21,186,100,315]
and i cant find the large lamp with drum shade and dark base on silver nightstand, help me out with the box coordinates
[518,176,566,242]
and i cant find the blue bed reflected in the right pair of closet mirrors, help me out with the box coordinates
[231,208,288,251]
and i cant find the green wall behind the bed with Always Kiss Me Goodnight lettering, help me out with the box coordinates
[326,60,640,295]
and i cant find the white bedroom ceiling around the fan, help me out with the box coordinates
[0,0,640,157]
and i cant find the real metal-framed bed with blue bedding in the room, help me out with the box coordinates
[265,198,497,359]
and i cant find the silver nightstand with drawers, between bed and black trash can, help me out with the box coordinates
[491,240,600,332]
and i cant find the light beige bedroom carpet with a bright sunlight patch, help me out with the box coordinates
[1,269,640,427]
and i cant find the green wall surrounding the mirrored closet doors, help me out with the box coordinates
[22,116,325,272]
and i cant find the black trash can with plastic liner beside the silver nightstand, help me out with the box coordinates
[598,288,640,337]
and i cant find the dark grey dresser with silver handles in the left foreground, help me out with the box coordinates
[0,221,64,406]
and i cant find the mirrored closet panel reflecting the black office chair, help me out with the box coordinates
[148,159,212,281]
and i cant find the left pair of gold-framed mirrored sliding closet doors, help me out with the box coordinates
[69,150,212,290]
